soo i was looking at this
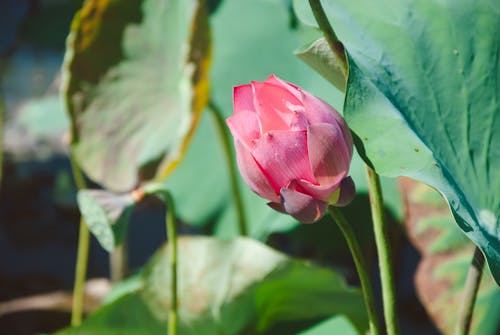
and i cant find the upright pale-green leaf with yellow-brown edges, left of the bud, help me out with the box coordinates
[63,0,209,191]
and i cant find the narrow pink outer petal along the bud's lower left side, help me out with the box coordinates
[234,139,279,202]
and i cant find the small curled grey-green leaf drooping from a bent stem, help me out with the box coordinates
[77,190,135,252]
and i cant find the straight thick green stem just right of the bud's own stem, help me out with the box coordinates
[366,166,399,335]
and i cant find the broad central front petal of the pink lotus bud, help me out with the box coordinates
[252,131,314,193]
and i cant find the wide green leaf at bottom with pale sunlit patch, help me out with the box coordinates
[58,237,367,335]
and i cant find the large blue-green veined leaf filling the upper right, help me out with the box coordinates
[296,0,500,283]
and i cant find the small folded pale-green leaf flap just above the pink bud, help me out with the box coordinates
[295,37,346,91]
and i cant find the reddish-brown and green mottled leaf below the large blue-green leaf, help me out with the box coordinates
[402,179,500,335]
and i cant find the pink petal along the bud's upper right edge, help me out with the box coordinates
[302,90,352,156]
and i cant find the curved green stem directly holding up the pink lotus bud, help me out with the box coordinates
[328,206,380,335]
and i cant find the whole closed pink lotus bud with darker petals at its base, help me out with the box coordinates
[226,75,354,223]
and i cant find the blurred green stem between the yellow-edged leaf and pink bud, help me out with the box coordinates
[209,101,248,236]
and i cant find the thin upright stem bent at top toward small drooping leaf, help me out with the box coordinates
[160,190,178,335]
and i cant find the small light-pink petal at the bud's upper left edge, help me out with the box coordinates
[226,110,260,150]
